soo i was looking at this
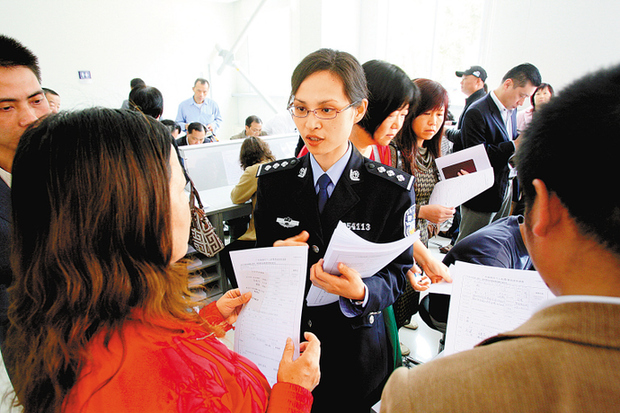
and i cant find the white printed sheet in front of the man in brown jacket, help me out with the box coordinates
[444,261,554,355]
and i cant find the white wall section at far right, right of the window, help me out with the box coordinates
[481,0,620,92]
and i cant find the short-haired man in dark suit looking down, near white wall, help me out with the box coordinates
[457,63,541,242]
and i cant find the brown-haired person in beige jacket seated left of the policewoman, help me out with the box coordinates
[220,136,276,288]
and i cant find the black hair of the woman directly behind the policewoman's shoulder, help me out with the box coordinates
[358,60,420,136]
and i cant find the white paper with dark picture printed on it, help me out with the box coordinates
[428,144,495,208]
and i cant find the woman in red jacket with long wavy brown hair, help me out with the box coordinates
[7,107,320,413]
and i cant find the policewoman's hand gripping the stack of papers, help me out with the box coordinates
[310,258,366,301]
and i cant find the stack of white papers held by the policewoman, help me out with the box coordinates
[306,222,420,307]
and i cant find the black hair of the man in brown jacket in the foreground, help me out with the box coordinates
[517,65,620,255]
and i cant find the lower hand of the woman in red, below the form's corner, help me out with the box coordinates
[278,332,321,391]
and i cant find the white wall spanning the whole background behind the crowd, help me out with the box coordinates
[0,0,620,135]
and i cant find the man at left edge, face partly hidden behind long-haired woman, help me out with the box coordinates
[0,35,50,358]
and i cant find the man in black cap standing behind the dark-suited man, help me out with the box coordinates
[439,66,487,254]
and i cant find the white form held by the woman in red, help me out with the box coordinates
[230,247,308,386]
